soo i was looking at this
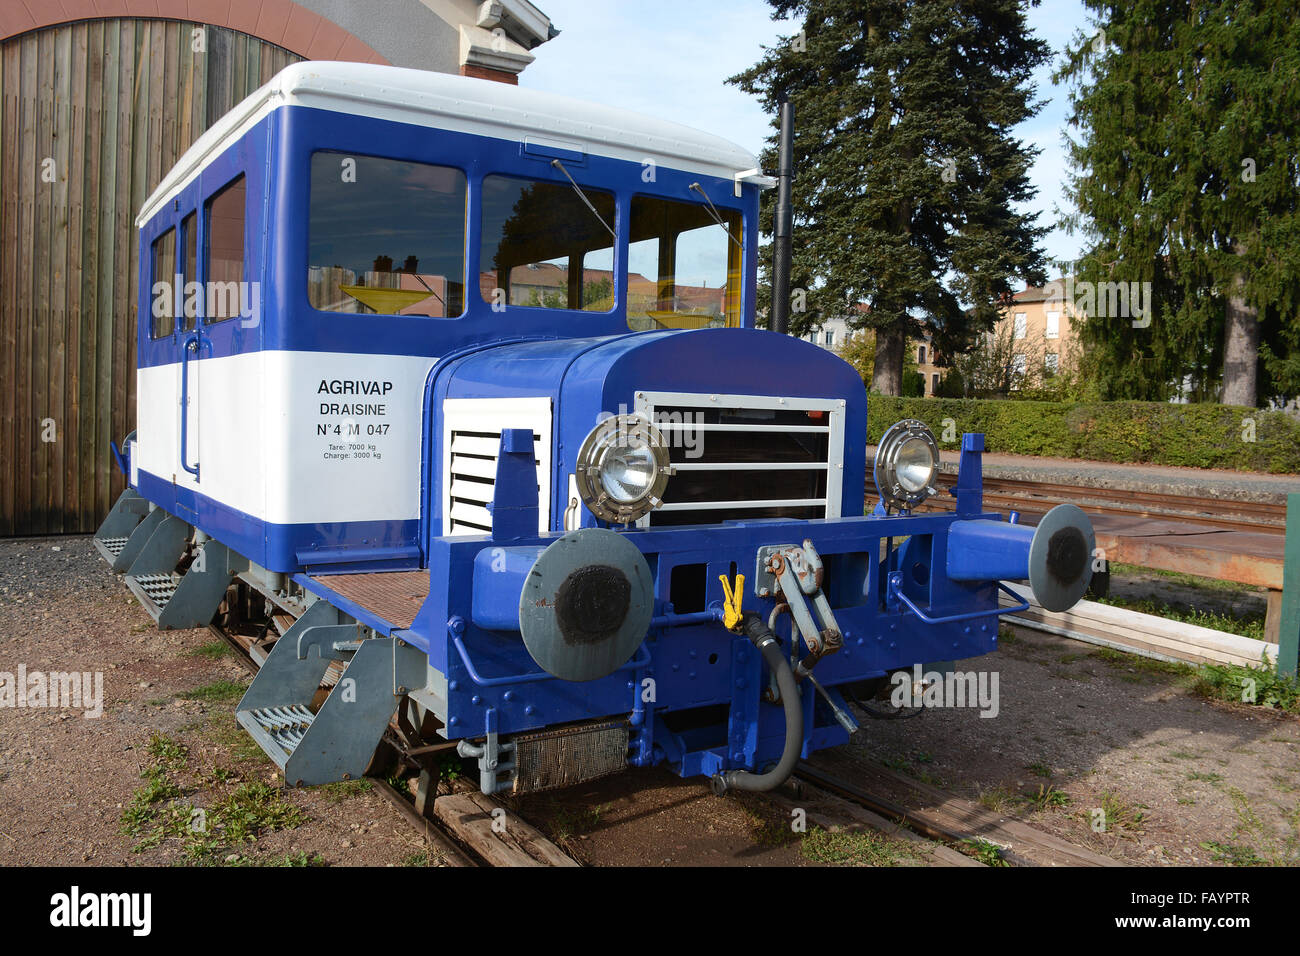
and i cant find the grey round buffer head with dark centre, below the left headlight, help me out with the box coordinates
[519,528,654,680]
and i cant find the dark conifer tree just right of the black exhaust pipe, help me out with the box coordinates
[731,0,1049,395]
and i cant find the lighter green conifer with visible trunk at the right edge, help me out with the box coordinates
[1057,0,1300,406]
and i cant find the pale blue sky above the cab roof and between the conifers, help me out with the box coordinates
[520,0,1091,278]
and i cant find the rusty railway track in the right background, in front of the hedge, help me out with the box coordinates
[926,473,1287,535]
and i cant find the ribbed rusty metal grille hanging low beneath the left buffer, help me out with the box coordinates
[514,721,628,793]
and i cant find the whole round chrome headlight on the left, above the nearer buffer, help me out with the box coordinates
[573,415,672,524]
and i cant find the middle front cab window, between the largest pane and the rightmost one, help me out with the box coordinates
[478,176,614,312]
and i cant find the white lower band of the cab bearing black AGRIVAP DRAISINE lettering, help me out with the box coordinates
[133,351,437,524]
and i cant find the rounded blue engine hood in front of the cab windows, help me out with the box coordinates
[433,329,867,528]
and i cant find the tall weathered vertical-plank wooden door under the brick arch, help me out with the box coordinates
[0,20,302,535]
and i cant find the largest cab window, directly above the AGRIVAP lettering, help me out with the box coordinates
[307,152,465,319]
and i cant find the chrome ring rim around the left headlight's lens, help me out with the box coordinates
[573,415,672,524]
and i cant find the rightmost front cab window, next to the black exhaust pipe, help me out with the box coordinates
[628,196,743,330]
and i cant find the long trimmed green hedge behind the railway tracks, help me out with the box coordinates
[867,395,1300,475]
